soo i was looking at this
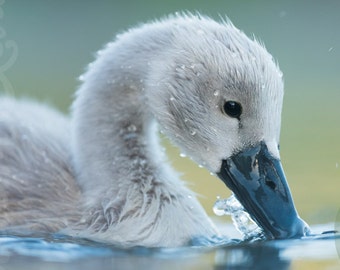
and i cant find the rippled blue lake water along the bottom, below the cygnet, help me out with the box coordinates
[0,224,340,270]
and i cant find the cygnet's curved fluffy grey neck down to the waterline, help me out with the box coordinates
[71,21,216,246]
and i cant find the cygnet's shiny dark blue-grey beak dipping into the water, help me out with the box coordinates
[217,142,310,239]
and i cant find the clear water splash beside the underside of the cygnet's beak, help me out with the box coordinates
[213,194,265,240]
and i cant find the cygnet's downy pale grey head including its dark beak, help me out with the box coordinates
[145,16,308,238]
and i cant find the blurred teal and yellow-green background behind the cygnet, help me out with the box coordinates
[0,0,340,227]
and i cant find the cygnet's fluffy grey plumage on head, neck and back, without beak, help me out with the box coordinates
[0,15,308,246]
